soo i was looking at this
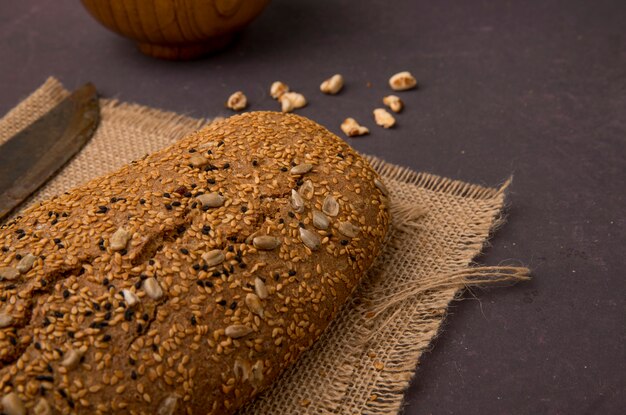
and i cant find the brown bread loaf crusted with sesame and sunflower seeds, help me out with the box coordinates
[0,112,389,415]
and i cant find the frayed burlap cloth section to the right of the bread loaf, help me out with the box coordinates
[240,160,529,415]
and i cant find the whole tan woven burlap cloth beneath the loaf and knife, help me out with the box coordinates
[0,78,528,414]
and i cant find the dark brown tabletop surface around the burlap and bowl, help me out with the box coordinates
[0,0,626,415]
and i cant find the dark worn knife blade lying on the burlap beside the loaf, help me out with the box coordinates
[0,83,100,220]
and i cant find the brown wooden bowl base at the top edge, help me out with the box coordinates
[81,0,270,60]
